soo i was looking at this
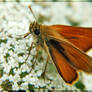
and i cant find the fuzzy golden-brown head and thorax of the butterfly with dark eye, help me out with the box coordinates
[29,22,53,47]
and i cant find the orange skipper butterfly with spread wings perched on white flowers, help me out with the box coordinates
[25,6,92,84]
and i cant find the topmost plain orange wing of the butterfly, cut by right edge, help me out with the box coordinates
[50,25,92,51]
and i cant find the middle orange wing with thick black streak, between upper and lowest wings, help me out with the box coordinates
[49,39,92,73]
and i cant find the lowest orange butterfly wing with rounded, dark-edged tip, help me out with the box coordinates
[49,41,78,84]
